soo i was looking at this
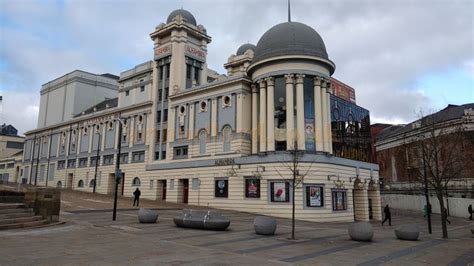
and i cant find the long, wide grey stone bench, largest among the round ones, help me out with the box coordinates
[173,210,230,231]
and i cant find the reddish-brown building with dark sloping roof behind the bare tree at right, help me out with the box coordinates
[375,103,474,197]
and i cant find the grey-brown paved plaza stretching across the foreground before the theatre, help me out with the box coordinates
[0,188,474,265]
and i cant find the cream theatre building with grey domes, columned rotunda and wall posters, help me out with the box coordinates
[23,9,381,221]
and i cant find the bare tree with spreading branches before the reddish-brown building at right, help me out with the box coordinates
[406,112,464,238]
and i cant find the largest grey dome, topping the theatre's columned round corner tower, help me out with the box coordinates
[253,22,329,63]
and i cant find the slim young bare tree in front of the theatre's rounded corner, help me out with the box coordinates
[275,143,313,240]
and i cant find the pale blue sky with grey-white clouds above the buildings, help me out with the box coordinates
[0,0,474,134]
